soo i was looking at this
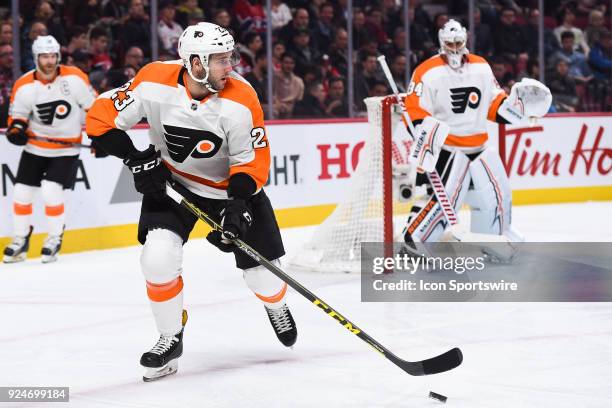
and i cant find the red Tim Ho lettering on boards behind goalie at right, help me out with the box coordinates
[499,124,612,177]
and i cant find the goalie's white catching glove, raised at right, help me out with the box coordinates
[497,78,552,125]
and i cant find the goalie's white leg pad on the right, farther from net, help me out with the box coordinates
[467,148,512,235]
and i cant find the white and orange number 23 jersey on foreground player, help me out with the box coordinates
[86,60,270,199]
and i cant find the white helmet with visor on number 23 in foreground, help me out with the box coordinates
[178,23,240,93]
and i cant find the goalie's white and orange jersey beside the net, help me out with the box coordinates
[405,54,507,150]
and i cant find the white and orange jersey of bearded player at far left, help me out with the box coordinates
[8,65,97,157]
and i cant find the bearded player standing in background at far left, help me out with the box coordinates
[3,35,96,263]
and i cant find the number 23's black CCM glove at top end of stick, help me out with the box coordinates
[123,145,170,201]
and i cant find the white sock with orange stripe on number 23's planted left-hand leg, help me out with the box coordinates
[140,228,183,336]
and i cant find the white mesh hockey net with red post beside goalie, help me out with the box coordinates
[291,96,410,273]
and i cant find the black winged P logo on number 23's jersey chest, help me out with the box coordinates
[164,125,223,163]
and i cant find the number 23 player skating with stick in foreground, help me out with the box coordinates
[86,23,297,381]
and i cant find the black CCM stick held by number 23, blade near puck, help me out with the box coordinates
[166,184,463,375]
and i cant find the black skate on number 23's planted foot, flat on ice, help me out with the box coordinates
[140,310,187,382]
